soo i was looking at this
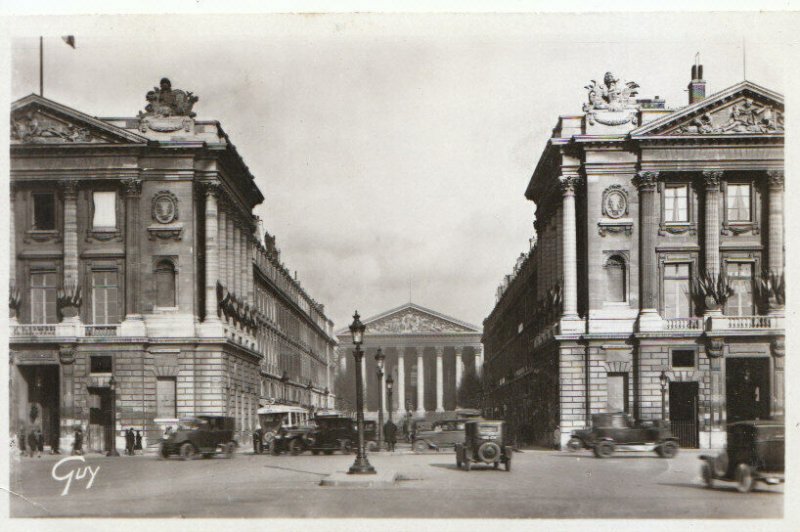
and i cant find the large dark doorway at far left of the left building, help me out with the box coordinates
[19,364,61,448]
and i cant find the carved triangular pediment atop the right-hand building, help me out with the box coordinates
[631,81,784,138]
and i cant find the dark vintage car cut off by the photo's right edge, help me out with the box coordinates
[700,419,786,493]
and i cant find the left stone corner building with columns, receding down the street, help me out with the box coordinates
[9,79,336,450]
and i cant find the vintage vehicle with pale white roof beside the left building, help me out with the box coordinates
[257,405,314,455]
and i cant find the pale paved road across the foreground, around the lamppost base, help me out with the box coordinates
[11,451,784,518]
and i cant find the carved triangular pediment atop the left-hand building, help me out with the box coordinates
[11,94,147,145]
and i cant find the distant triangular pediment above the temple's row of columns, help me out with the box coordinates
[364,304,480,335]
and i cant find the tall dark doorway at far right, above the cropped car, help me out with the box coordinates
[725,358,770,423]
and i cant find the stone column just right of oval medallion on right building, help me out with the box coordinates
[633,172,662,331]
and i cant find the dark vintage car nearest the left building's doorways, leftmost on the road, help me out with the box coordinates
[159,416,237,460]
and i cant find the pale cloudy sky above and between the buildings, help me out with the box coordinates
[9,13,800,329]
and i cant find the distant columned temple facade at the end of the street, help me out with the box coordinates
[336,303,483,418]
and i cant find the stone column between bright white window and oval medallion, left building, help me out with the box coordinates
[120,177,147,336]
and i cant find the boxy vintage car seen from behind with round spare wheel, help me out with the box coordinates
[456,419,512,471]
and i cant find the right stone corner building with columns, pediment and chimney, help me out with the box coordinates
[483,65,784,447]
